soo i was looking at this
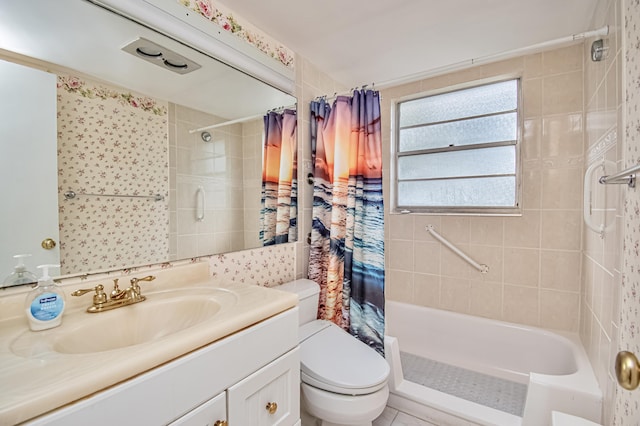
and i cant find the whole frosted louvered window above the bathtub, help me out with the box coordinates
[393,79,520,215]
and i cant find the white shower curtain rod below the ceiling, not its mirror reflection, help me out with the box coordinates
[378,25,609,88]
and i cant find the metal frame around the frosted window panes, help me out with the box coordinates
[390,75,524,216]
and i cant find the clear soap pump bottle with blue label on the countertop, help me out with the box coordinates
[25,265,65,331]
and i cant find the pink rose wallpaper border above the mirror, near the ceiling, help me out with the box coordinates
[178,0,294,68]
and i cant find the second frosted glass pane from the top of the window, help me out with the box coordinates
[399,112,518,152]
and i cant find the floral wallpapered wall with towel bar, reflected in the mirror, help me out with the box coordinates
[58,76,169,274]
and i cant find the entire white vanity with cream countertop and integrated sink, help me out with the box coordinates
[0,265,300,426]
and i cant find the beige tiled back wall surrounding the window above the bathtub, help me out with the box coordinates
[382,44,584,331]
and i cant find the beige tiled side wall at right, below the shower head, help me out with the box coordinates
[580,0,624,424]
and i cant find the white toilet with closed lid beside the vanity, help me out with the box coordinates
[275,279,389,426]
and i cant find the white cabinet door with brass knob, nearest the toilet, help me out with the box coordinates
[227,348,300,426]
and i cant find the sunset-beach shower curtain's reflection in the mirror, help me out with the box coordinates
[260,110,298,246]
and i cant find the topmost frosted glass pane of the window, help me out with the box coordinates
[400,80,518,127]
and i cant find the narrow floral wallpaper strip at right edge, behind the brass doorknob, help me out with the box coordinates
[614,0,640,425]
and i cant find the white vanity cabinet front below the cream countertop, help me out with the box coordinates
[27,308,300,426]
